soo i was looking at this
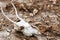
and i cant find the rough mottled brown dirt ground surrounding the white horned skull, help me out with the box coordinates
[0,0,60,40]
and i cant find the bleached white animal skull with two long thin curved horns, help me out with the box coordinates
[1,2,40,36]
